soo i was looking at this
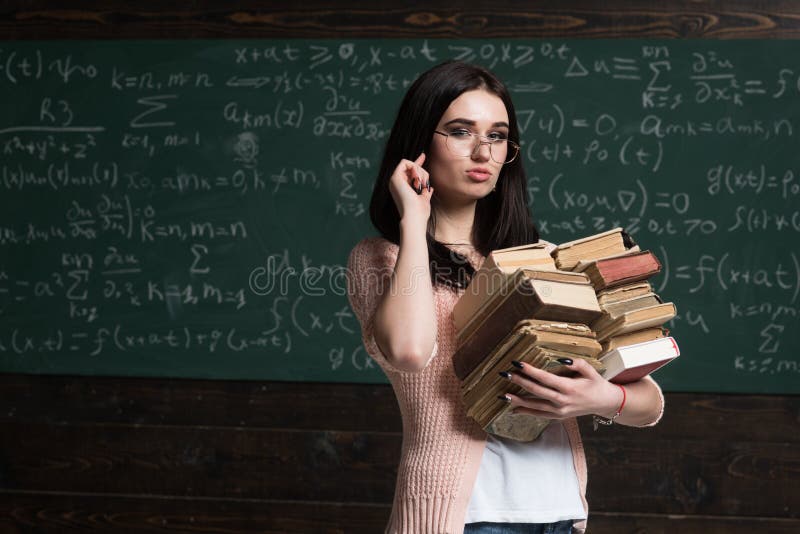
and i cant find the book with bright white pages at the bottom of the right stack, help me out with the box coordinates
[600,337,681,384]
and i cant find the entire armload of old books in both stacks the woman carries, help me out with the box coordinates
[453,228,680,441]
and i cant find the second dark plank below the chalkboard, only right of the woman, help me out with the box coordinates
[586,440,800,518]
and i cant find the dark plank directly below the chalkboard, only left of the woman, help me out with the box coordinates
[0,374,401,432]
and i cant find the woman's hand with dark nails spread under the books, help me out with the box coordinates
[506,358,622,419]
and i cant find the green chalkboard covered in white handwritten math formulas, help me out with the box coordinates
[0,40,800,393]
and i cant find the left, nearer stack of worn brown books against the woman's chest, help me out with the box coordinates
[453,263,603,441]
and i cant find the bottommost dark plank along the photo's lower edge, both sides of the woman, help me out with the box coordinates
[0,493,800,534]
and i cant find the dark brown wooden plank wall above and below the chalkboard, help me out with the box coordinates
[0,0,800,534]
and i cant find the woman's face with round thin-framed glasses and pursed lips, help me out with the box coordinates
[428,89,509,204]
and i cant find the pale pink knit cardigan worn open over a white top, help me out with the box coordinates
[348,238,664,534]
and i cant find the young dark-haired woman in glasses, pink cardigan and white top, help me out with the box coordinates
[348,61,663,534]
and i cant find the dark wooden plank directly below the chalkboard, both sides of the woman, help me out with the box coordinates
[0,374,800,443]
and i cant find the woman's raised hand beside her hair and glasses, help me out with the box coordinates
[389,152,433,225]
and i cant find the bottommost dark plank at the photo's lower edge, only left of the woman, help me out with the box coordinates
[0,493,391,534]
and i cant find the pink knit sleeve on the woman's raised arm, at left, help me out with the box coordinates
[347,238,438,373]
